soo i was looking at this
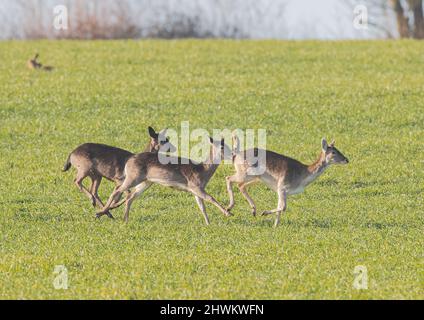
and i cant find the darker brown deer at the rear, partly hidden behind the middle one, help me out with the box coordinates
[63,127,176,218]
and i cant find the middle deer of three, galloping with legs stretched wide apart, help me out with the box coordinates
[98,138,231,225]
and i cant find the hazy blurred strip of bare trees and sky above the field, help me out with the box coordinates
[0,0,424,39]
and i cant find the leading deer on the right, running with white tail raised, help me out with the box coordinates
[226,133,349,227]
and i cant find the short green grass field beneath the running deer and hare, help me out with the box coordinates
[0,40,424,299]
